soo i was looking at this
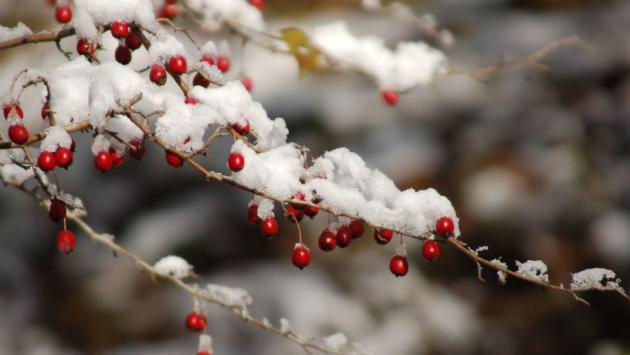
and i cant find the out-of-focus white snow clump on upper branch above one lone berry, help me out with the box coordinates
[312,21,446,91]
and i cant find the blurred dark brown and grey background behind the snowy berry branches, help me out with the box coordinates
[0,0,630,355]
